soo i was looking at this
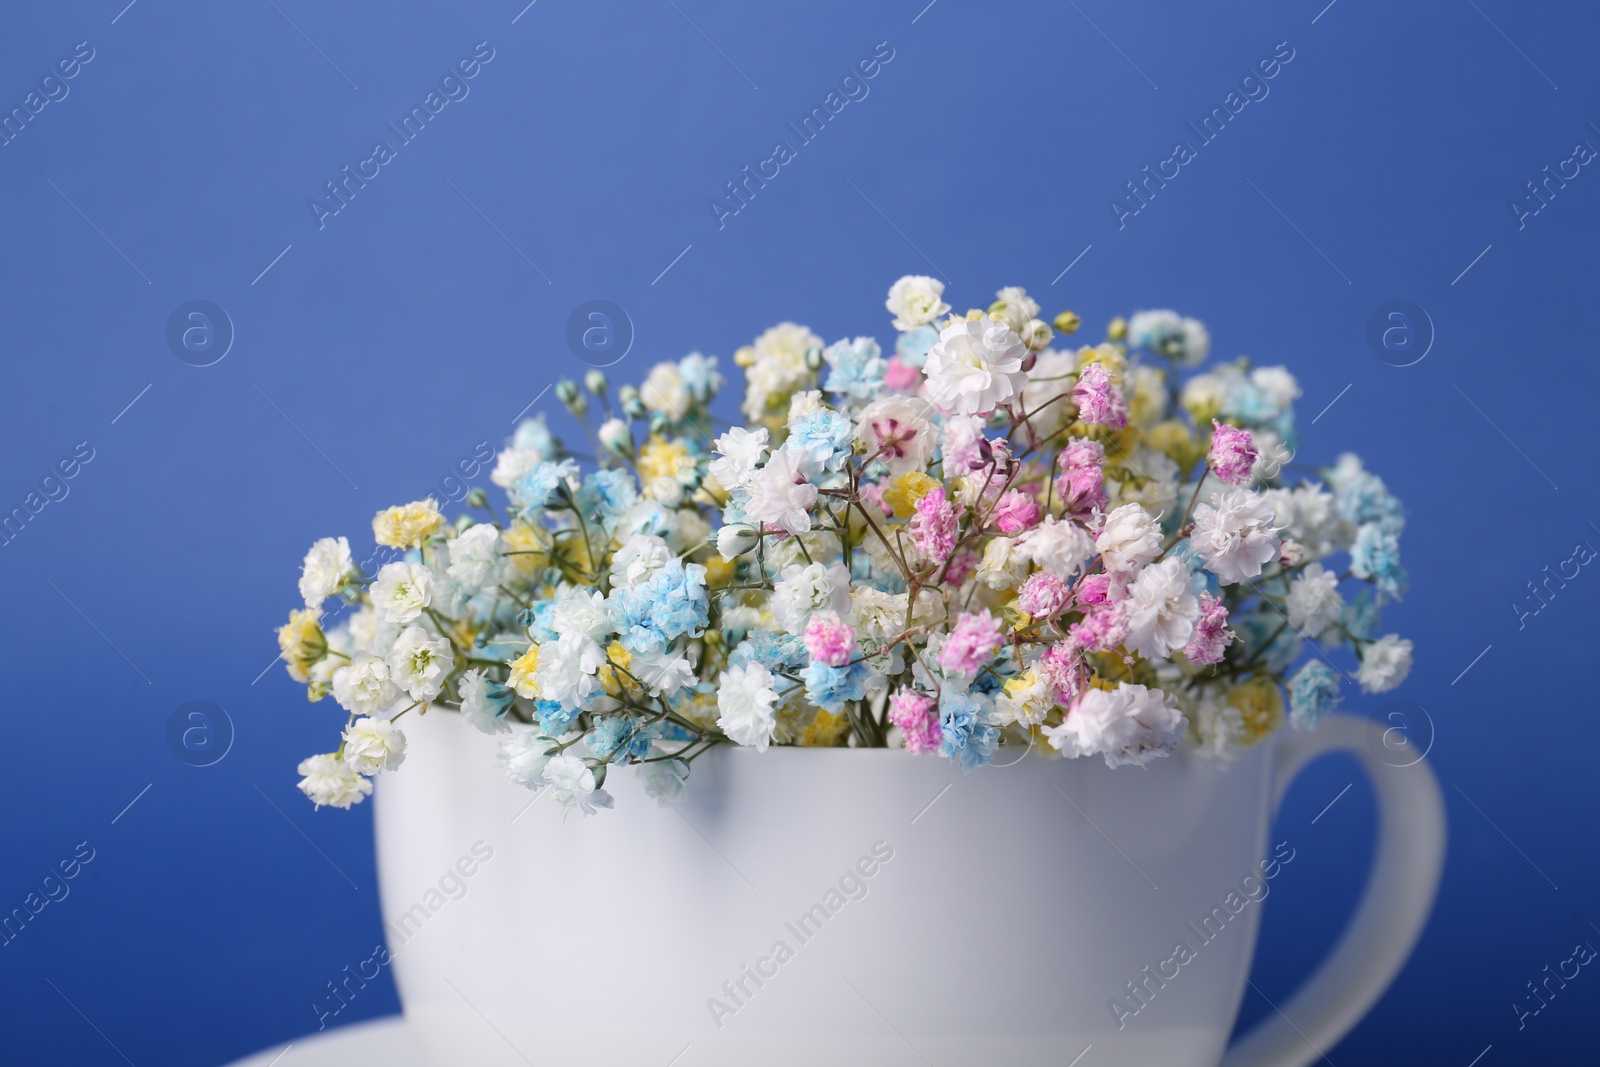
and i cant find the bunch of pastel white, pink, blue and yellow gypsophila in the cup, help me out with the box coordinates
[278,277,1411,813]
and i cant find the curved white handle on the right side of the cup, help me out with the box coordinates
[1219,715,1445,1067]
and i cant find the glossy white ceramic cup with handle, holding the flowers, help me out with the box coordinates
[376,710,1445,1067]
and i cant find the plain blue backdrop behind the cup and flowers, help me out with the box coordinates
[0,0,1600,1067]
